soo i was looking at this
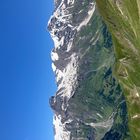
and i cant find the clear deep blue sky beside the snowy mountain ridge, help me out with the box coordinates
[0,0,56,140]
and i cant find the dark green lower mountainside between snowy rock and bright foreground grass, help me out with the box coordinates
[67,0,127,140]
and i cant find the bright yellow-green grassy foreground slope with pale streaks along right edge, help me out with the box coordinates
[96,0,140,140]
